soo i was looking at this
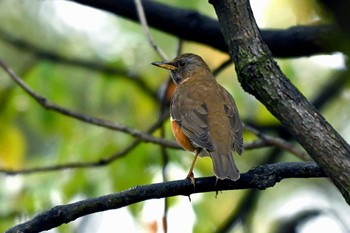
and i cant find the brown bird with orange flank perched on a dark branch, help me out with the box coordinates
[152,53,243,184]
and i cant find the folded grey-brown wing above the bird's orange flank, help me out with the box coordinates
[171,102,214,151]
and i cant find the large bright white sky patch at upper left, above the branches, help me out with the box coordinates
[42,1,132,59]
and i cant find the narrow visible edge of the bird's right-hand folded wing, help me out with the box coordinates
[224,94,243,154]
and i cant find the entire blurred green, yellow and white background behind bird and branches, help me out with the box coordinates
[0,0,350,233]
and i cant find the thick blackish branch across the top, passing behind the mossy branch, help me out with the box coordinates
[71,0,340,58]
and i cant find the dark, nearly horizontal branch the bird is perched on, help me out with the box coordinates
[6,162,325,233]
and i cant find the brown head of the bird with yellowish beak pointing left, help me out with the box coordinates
[152,53,211,84]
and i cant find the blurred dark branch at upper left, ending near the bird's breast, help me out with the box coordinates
[0,30,156,99]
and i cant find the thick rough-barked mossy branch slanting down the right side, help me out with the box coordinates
[212,0,350,203]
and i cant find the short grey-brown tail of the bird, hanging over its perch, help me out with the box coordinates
[210,150,240,181]
